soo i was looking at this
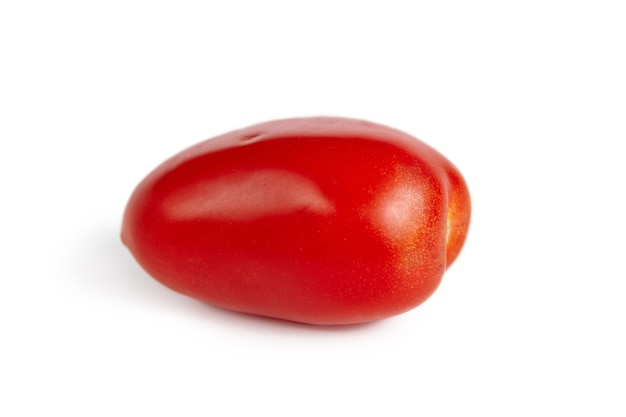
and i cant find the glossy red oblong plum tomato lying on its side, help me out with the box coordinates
[122,117,470,325]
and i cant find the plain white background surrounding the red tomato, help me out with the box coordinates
[0,0,626,416]
